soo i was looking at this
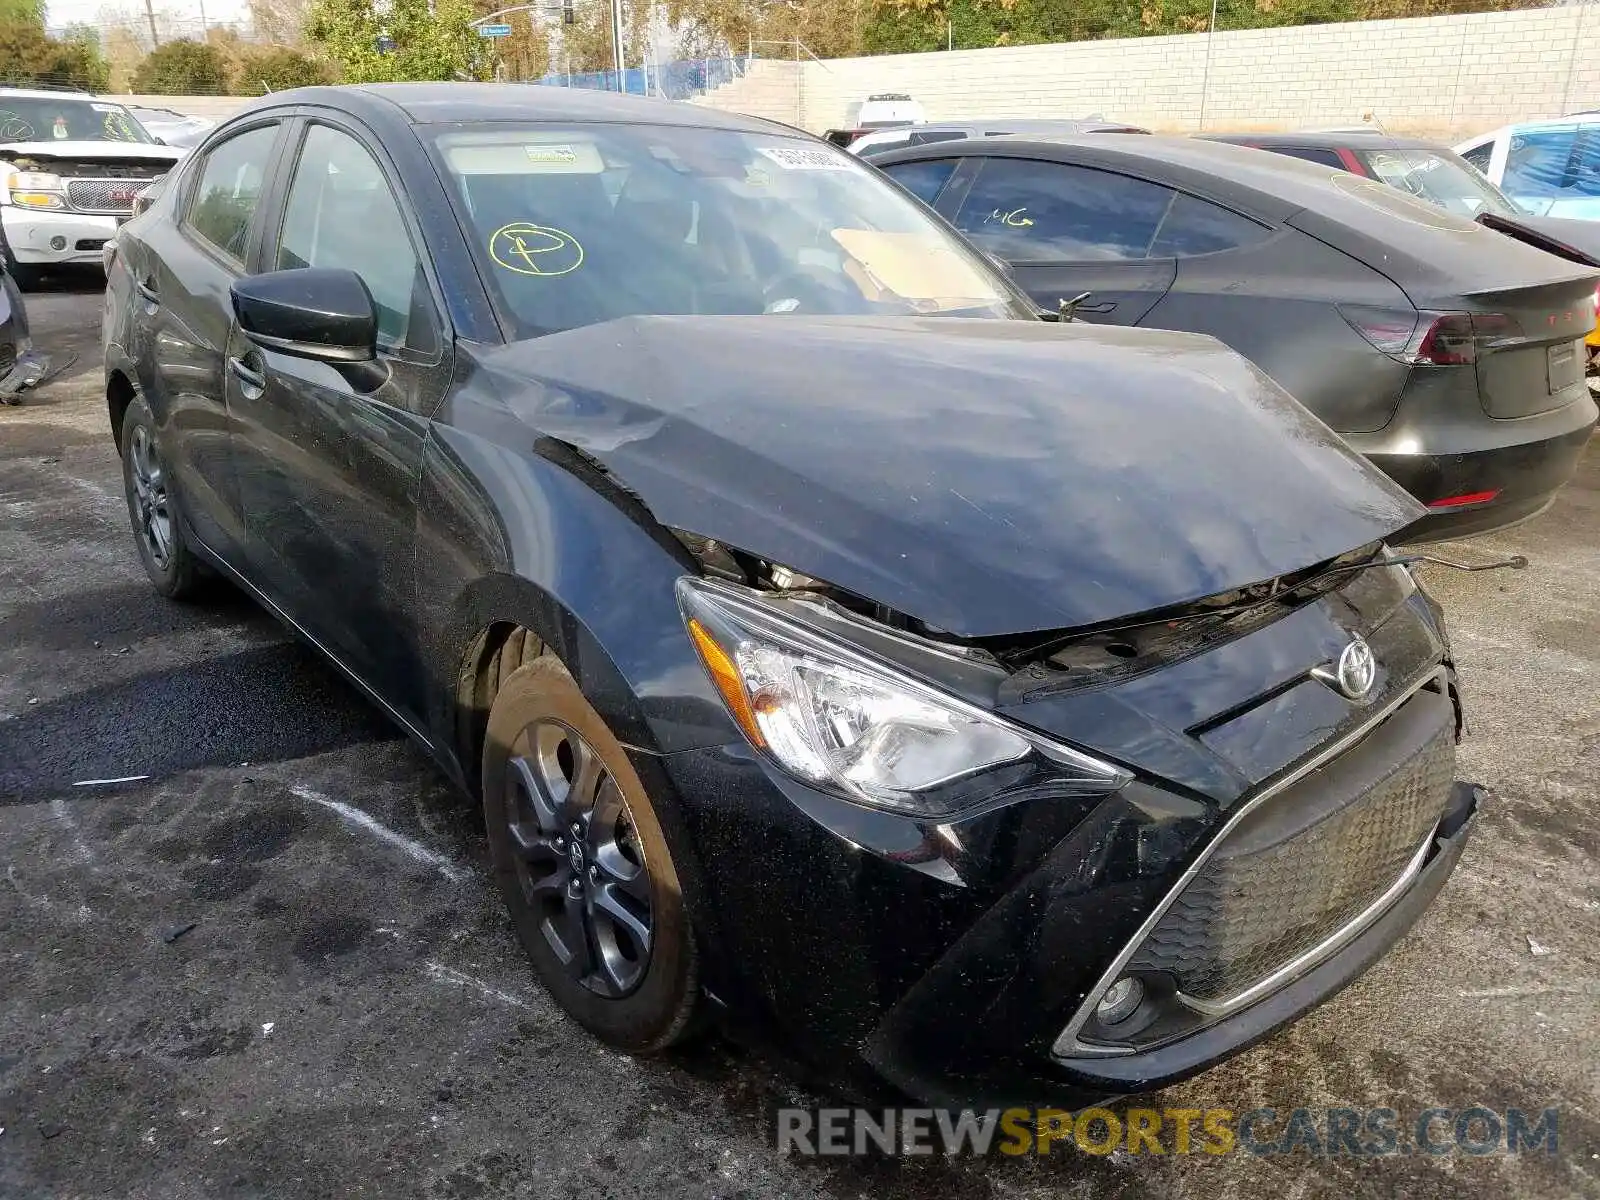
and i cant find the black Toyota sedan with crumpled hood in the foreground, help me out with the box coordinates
[104,85,1477,1106]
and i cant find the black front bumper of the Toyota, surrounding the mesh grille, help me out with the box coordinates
[642,633,1477,1109]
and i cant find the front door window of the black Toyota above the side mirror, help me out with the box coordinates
[277,125,430,349]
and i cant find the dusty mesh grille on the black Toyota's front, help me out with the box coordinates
[1130,713,1456,1003]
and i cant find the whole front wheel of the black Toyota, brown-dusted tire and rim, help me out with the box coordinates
[483,654,699,1054]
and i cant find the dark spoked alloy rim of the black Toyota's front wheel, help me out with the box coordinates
[506,720,654,998]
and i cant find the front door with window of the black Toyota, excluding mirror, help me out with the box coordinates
[227,115,451,730]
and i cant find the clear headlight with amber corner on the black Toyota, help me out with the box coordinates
[678,578,1130,816]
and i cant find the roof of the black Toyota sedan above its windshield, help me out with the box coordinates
[233,83,796,138]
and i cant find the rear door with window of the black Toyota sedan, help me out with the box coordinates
[128,114,285,565]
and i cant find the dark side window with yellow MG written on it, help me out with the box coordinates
[955,158,1173,262]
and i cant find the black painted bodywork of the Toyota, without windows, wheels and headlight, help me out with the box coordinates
[104,85,1474,1106]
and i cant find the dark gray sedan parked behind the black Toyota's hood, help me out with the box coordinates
[872,133,1597,539]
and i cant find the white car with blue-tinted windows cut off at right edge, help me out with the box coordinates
[1456,112,1600,221]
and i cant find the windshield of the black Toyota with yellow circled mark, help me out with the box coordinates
[435,125,1034,338]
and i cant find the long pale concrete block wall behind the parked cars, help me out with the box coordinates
[696,3,1600,139]
